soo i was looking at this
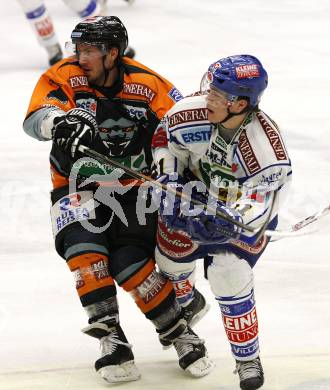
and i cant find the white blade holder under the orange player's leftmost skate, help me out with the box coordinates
[98,361,141,383]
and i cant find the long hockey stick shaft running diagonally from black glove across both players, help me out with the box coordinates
[78,145,262,233]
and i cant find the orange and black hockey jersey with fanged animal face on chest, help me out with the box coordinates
[24,57,182,187]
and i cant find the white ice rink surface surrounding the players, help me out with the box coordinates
[0,0,330,390]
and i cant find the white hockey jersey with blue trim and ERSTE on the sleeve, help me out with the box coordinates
[154,95,292,245]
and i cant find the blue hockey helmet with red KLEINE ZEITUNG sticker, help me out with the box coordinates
[207,54,268,108]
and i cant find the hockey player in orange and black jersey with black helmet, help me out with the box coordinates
[24,16,213,382]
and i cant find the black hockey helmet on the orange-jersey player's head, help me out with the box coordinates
[71,16,128,56]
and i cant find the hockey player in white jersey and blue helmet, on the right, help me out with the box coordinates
[154,55,291,390]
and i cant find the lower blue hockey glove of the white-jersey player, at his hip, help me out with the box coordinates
[187,202,242,244]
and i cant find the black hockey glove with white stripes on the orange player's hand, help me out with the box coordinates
[52,108,98,158]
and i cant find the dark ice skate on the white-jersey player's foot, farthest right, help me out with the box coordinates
[235,357,264,390]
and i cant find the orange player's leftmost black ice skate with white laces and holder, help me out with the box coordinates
[83,323,141,383]
